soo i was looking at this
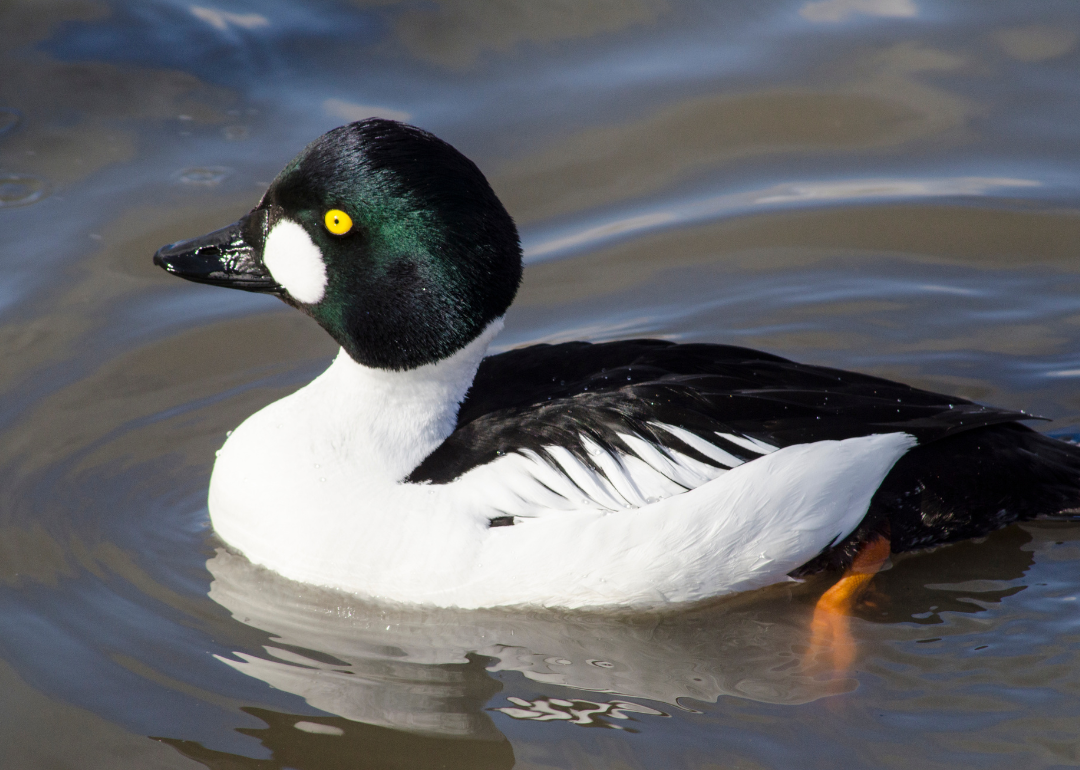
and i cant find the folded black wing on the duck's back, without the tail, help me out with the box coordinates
[407,339,1032,484]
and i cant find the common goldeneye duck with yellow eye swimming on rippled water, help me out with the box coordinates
[154,119,1080,607]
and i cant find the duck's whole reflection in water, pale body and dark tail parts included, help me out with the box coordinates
[187,527,1032,768]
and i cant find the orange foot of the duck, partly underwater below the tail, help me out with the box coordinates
[810,535,889,675]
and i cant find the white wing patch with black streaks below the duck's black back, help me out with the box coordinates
[454,422,777,518]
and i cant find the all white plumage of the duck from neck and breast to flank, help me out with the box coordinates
[210,320,915,607]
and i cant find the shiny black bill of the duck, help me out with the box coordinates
[153,212,282,294]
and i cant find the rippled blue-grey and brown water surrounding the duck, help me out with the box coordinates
[0,0,1080,770]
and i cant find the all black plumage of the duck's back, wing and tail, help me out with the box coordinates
[406,339,1080,573]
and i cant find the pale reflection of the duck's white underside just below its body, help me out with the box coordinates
[207,550,854,737]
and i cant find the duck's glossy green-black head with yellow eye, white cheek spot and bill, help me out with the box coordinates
[153,119,522,369]
